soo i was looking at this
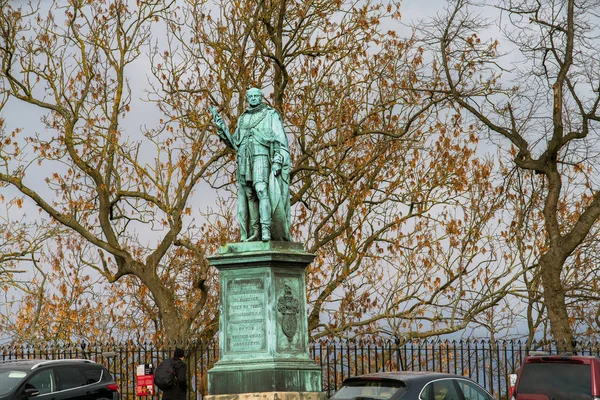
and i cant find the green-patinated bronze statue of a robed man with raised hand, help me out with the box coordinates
[211,88,290,242]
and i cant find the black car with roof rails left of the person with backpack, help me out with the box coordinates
[0,359,120,400]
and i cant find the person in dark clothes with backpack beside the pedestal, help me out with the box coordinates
[154,347,187,400]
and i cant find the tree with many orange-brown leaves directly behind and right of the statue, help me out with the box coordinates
[162,0,520,338]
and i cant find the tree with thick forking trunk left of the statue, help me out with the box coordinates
[0,1,221,340]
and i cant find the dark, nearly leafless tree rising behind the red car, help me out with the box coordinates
[429,0,600,348]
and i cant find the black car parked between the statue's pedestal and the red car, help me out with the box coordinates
[331,371,493,400]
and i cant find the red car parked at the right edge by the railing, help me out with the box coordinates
[512,355,600,400]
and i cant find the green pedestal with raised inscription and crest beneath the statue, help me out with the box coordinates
[208,242,322,398]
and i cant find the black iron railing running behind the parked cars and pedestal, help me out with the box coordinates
[0,340,600,400]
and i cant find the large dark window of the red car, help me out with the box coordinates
[518,363,592,400]
